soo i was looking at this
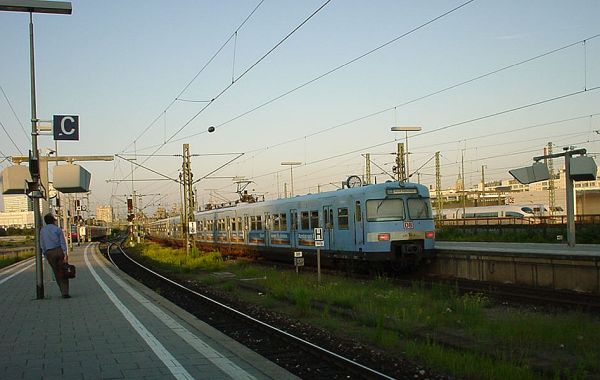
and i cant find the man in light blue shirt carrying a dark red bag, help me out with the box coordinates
[40,214,71,298]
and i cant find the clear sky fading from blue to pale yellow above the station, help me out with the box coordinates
[0,0,600,214]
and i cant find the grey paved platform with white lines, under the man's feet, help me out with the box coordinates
[0,244,296,379]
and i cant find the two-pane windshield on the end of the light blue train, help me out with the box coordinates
[367,198,432,222]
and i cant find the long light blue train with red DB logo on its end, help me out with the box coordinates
[145,182,435,269]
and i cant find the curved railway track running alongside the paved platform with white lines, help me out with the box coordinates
[104,244,445,379]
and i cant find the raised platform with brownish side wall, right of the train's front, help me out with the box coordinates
[428,242,600,294]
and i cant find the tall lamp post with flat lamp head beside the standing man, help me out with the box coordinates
[0,0,72,299]
